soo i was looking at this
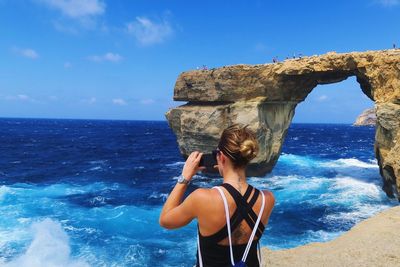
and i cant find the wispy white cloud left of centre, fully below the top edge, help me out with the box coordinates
[126,17,173,45]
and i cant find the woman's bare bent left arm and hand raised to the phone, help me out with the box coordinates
[160,151,204,229]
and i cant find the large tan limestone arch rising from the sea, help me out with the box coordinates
[166,50,400,201]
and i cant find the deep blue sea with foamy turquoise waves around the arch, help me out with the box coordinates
[0,119,397,267]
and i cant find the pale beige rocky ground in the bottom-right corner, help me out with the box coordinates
[262,206,400,267]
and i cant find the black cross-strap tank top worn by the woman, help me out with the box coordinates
[196,184,265,267]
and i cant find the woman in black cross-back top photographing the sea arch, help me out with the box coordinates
[160,124,275,267]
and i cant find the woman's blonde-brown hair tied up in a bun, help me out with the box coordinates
[218,124,259,167]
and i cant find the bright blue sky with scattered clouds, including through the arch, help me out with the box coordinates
[0,0,400,123]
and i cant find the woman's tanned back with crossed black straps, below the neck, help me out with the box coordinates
[198,183,274,266]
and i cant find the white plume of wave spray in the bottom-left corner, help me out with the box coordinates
[1,219,89,267]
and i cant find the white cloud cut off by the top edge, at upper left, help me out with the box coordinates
[38,0,106,18]
